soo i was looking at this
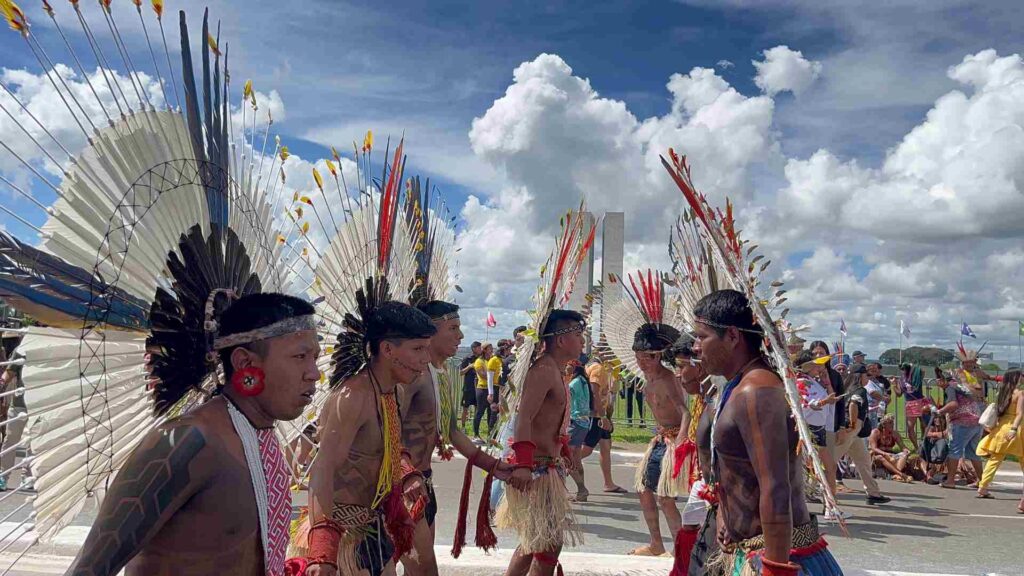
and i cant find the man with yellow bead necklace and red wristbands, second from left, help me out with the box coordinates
[305,301,437,576]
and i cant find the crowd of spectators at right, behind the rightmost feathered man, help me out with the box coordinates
[787,335,1024,520]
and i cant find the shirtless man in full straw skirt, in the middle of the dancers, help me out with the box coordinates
[497,310,585,576]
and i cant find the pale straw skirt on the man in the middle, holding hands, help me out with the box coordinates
[496,461,583,553]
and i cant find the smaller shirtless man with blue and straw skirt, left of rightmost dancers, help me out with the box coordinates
[630,323,690,556]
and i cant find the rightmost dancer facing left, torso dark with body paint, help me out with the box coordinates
[693,290,842,576]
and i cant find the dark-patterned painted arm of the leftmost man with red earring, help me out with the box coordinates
[67,422,210,576]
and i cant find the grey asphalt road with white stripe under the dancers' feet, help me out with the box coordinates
[0,454,1024,576]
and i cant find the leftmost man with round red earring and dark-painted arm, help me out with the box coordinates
[68,293,321,576]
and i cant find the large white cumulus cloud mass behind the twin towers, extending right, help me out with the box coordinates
[460,46,1024,355]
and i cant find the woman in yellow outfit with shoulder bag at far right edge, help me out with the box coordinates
[978,370,1024,513]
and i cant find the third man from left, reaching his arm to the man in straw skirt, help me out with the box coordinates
[398,300,512,576]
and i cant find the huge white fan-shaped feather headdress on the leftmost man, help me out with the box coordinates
[0,2,346,540]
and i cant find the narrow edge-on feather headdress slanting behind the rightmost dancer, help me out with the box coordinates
[662,149,842,518]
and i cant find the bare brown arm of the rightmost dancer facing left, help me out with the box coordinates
[735,373,793,564]
